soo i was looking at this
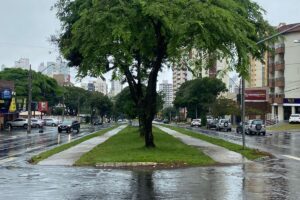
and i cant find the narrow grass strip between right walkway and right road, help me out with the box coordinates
[165,125,271,160]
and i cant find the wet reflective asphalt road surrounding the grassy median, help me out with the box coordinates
[0,124,300,200]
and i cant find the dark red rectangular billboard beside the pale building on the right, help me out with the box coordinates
[245,88,268,102]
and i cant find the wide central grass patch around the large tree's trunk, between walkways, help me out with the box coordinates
[75,127,215,166]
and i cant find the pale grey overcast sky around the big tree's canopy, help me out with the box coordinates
[0,0,300,84]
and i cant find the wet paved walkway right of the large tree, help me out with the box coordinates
[156,125,251,164]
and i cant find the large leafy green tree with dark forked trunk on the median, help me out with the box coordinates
[56,0,271,147]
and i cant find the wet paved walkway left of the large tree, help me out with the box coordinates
[38,125,127,166]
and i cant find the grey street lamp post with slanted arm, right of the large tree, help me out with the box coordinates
[241,23,300,149]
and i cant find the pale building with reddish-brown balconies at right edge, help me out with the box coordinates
[268,24,300,120]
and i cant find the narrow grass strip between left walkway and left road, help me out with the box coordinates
[29,126,118,164]
